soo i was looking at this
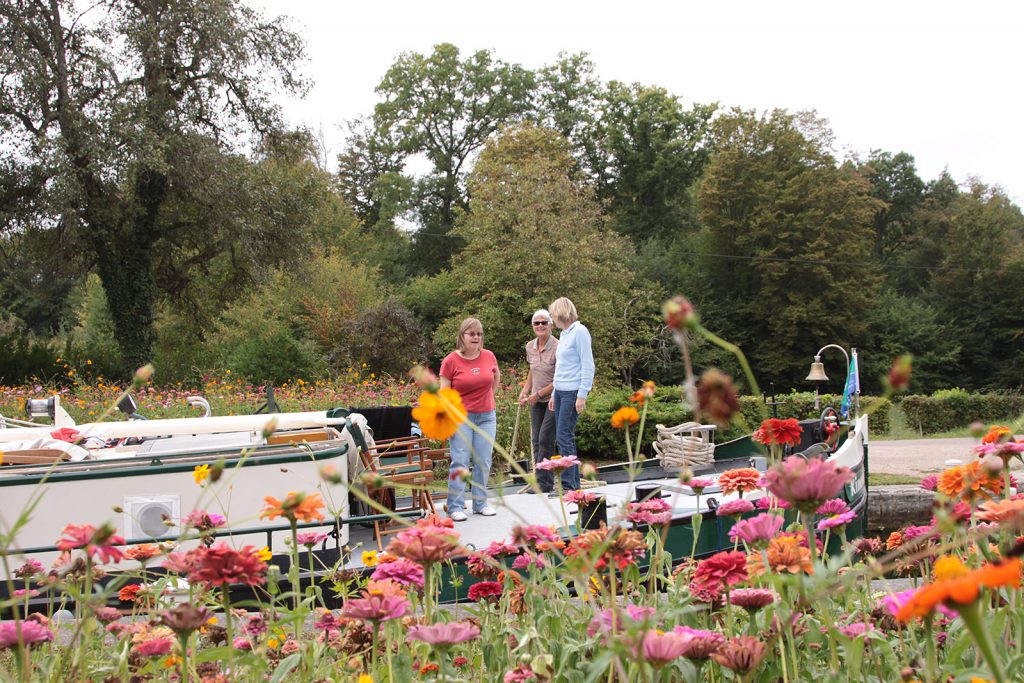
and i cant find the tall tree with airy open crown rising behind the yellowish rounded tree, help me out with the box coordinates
[374,43,534,272]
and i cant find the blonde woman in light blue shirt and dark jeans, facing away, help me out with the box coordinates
[550,297,594,490]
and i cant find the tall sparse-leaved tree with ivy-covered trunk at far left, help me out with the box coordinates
[0,0,303,374]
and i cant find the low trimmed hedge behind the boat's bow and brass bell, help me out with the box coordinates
[577,386,892,460]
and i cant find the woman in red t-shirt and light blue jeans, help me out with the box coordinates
[441,317,502,522]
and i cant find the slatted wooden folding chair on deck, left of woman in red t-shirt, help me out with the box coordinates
[359,436,434,550]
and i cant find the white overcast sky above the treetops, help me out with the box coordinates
[250,0,1024,204]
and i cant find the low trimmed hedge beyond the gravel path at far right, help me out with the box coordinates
[900,390,1024,434]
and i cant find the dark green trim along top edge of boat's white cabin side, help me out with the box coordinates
[0,443,348,487]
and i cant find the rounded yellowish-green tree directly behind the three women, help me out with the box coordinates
[434,125,660,377]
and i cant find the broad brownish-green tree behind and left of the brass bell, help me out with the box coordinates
[697,110,879,386]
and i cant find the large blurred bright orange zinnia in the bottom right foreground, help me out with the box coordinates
[896,556,1021,622]
